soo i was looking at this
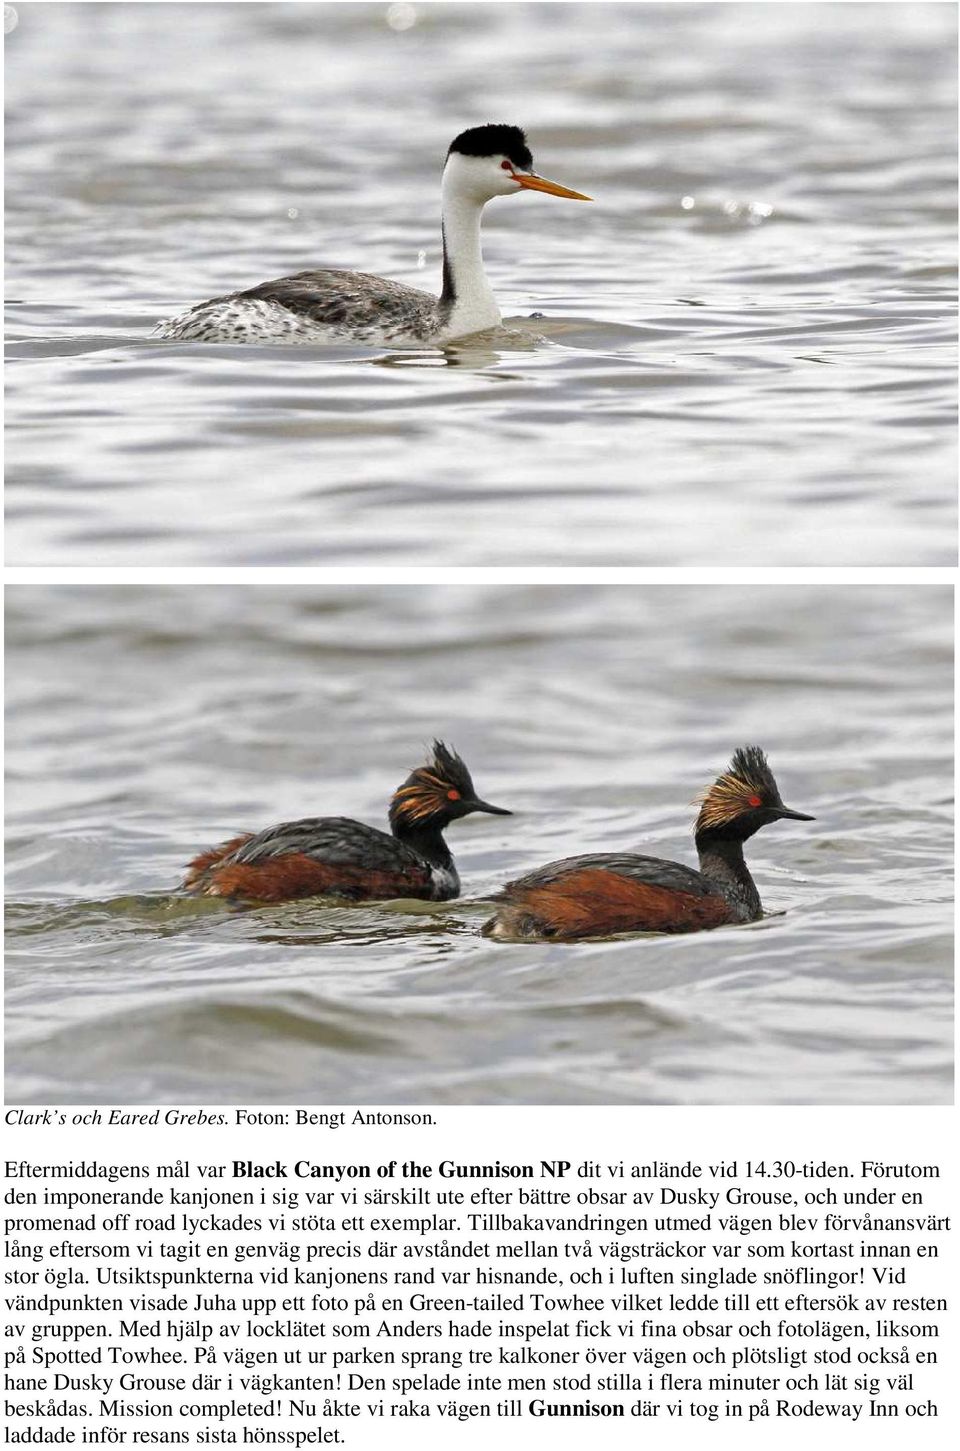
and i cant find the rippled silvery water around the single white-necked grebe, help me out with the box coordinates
[7,3,956,564]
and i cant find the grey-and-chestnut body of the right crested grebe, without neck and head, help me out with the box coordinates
[484,855,729,942]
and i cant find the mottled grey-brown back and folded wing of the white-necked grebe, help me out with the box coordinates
[233,267,436,328]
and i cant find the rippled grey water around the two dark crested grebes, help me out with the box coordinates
[6,585,953,1104]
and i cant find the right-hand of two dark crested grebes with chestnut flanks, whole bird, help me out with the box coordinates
[483,746,814,942]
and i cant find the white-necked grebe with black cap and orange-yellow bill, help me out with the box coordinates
[154,126,590,345]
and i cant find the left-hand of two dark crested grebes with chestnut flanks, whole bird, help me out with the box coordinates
[183,740,512,903]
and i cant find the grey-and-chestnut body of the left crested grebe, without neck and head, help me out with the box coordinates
[184,817,431,901]
